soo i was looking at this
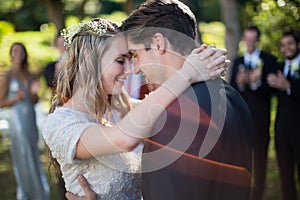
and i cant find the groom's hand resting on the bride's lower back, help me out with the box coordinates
[66,175,97,200]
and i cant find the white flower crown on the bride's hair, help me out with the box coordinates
[61,20,108,47]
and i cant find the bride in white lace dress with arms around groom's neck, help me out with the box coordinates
[43,18,226,199]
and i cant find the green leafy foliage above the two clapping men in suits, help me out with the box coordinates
[244,0,300,59]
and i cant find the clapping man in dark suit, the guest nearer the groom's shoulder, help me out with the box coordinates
[230,26,276,200]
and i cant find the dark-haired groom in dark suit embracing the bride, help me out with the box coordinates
[67,0,253,200]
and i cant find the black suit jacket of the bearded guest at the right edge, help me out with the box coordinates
[275,63,300,133]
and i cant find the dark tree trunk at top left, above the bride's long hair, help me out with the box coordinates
[45,0,65,33]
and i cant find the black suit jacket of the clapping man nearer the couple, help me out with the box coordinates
[230,52,276,131]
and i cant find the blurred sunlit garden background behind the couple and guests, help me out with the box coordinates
[0,0,300,200]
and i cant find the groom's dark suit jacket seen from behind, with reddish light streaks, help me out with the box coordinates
[142,79,254,200]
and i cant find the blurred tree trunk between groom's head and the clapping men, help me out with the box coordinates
[219,0,241,80]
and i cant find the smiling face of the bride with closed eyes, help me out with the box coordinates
[101,35,132,94]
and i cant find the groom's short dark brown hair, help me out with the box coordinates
[120,0,197,54]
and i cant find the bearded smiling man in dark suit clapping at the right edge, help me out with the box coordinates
[267,31,300,200]
